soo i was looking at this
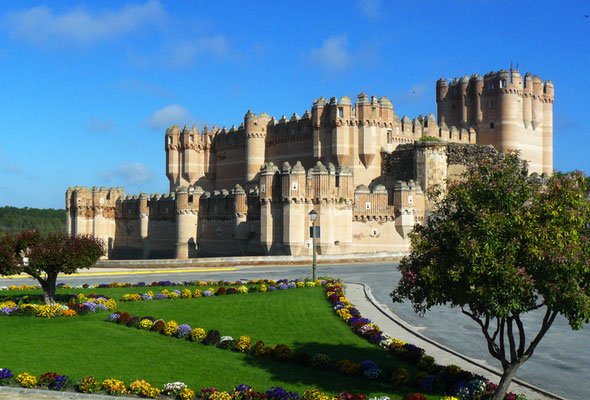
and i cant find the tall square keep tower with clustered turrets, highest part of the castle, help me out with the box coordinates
[436,68,554,174]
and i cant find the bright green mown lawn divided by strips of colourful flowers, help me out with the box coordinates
[0,287,438,398]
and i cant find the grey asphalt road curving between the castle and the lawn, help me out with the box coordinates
[0,263,590,400]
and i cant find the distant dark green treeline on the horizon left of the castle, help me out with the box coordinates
[0,206,66,234]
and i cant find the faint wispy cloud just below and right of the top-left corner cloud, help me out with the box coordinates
[128,35,230,68]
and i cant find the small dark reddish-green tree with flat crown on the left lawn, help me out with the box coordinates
[0,231,104,304]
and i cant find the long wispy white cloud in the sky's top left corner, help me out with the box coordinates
[1,0,166,44]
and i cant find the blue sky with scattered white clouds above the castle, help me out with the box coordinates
[0,0,590,208]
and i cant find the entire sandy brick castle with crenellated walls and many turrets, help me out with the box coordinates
[66,68,554,259]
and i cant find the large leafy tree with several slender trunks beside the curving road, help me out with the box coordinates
[391,154,590,399]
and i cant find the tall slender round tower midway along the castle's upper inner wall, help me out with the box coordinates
[244,110,270,182]
